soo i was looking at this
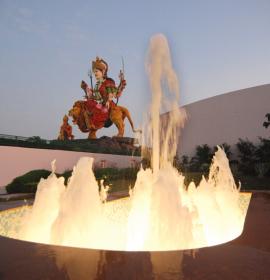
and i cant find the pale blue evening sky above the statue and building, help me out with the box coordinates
[0,0,270,139]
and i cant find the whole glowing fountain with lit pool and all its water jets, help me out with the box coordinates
[0,35,250,251]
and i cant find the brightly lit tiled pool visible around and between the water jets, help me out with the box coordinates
[0,184,251,251]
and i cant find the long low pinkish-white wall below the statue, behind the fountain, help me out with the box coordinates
[0,146,141,187]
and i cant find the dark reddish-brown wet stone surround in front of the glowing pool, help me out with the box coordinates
[0,192,270,280]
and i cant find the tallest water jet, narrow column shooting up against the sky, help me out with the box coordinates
[144,34,186,173]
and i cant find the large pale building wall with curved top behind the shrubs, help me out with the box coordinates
[178,85,270,156]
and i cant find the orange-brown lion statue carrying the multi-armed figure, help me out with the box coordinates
[68,100,138,139]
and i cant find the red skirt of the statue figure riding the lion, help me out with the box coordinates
[85,99,109,129]
